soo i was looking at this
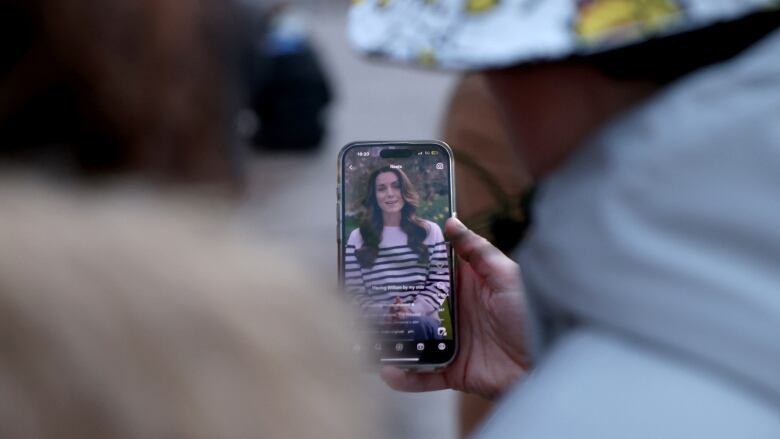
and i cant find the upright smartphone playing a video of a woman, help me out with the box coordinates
[337,140,458,370]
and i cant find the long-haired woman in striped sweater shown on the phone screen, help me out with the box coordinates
[344,166,450,340]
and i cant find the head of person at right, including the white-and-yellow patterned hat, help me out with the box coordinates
[349,0,780,177]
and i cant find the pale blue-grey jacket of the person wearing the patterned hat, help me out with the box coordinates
[482,28,780,439]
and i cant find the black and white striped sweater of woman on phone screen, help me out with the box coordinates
[344,221,450,316]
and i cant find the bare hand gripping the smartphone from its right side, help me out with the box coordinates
[382,219,530,399]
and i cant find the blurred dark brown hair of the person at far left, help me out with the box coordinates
[0,0,248,186]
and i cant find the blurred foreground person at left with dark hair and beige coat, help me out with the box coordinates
[0,0,378,439]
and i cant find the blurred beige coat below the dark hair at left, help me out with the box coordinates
[0,178,376,439]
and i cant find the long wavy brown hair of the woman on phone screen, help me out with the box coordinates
[355,166,428,268]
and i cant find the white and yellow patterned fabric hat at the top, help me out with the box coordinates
[349,0,780,69]
